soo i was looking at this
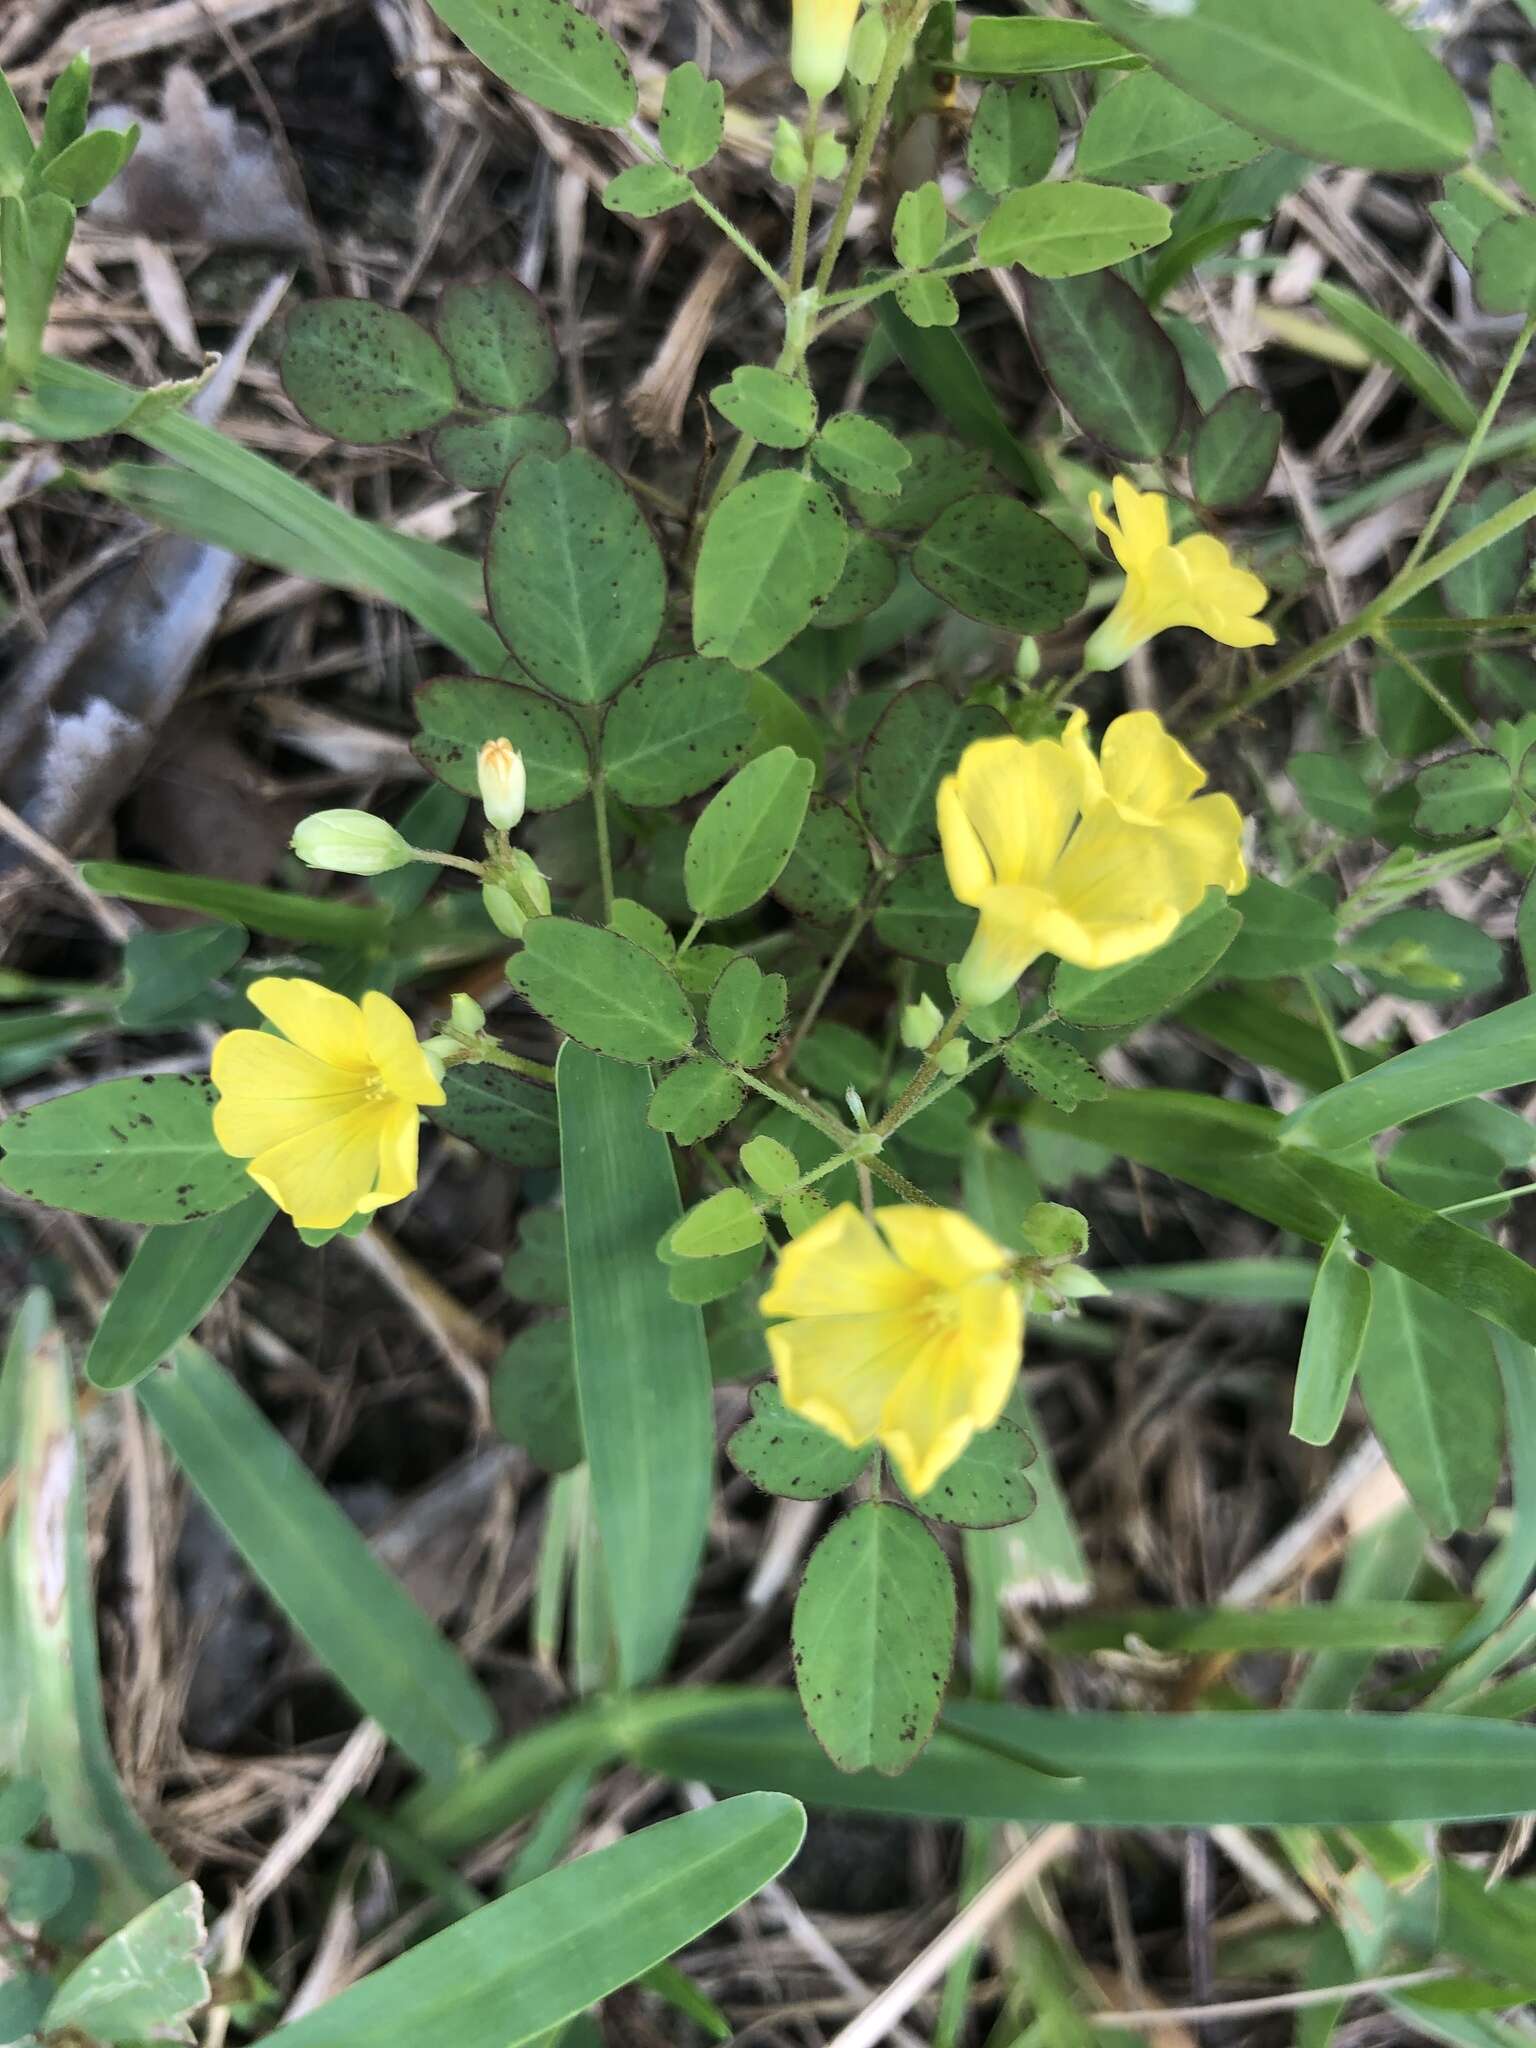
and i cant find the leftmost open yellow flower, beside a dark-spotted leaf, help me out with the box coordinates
[213,975,444,1231]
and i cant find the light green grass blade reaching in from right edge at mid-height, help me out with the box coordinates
[1280,995,1536,1153]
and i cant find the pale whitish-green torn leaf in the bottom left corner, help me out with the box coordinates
[43,1884,209,2042]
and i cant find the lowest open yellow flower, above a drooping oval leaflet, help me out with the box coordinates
[762,1202,1024,1497]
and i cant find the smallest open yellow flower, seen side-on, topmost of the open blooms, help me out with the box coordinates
[1083,477,1274,670]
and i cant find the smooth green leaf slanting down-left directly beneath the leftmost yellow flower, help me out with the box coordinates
[86,1188,276,1393]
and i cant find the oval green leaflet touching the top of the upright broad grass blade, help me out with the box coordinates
[506,918,696,1065]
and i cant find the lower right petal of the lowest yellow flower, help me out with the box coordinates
[879,1280,1024,1497]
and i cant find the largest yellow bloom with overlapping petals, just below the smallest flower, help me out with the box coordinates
[938,711,1247,1004]
